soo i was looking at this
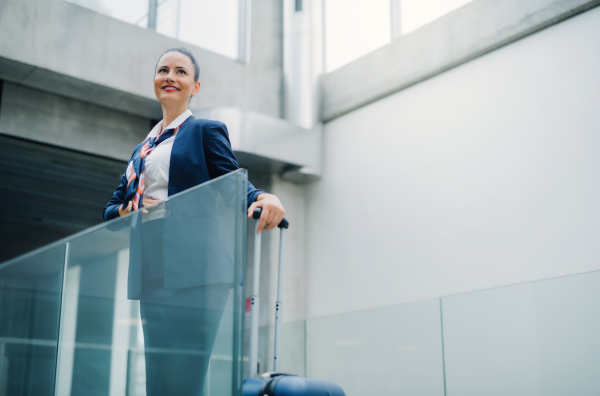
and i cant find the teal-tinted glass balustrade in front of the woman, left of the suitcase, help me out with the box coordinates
[0,170,247,396]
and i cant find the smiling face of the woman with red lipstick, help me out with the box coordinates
[154,51,200,106]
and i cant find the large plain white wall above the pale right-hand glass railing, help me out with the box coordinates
[306,8,600,317]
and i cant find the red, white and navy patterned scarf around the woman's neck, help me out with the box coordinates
[123,118,187,210]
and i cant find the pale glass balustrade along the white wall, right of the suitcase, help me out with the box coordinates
[294,271,600,396]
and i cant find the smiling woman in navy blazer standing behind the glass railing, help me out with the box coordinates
[104,48,285,396]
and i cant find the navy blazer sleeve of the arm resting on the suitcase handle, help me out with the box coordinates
[203,122,265,207]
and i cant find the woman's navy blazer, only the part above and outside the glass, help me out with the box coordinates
[104,116,264,221]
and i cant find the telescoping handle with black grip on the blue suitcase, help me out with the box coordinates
[248,208,290,378]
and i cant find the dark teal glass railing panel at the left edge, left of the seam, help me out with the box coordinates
[0,244,65,396]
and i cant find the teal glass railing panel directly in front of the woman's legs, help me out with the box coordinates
[56,170,247,396]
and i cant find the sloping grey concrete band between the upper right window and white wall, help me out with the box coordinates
[322,0,600,121]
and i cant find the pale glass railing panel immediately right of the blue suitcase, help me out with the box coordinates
[308,299,444,396]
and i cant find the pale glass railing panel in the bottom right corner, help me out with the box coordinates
[442,272,600,396]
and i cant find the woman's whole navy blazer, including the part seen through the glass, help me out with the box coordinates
[104,116,264,299]
